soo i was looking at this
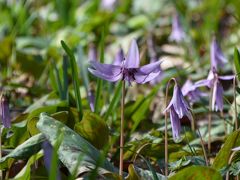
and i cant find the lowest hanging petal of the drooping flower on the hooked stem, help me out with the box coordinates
[170,108,181,139]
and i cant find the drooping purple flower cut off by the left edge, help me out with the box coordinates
[0,95,11,128]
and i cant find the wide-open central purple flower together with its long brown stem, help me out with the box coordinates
[89,40,161,176]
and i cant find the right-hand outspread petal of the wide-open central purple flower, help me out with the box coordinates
[134,61,161,84]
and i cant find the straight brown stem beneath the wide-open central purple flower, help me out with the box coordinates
[119,80,125,176]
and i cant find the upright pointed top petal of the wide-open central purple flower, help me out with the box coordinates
[125,39,140,68]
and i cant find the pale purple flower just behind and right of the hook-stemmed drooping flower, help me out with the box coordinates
[182,79,206,103]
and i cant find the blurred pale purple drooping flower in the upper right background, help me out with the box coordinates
[169,14,186,43]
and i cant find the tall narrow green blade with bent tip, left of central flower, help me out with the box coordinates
[61,41,83,121]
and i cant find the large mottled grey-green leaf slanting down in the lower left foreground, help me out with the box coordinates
[37,113,114,174]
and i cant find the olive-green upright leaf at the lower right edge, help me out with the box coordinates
[213,130,240,170]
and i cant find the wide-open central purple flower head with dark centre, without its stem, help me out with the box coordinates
[88,40,161,84]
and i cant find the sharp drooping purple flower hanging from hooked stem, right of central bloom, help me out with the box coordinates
[164,79,192,139]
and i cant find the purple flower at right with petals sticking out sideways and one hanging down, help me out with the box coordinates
[194,68,234,111]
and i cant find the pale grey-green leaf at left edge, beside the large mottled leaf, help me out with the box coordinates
[0,134,46,169]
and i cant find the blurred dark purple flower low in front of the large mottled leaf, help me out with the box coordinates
[42,141,61,180]
